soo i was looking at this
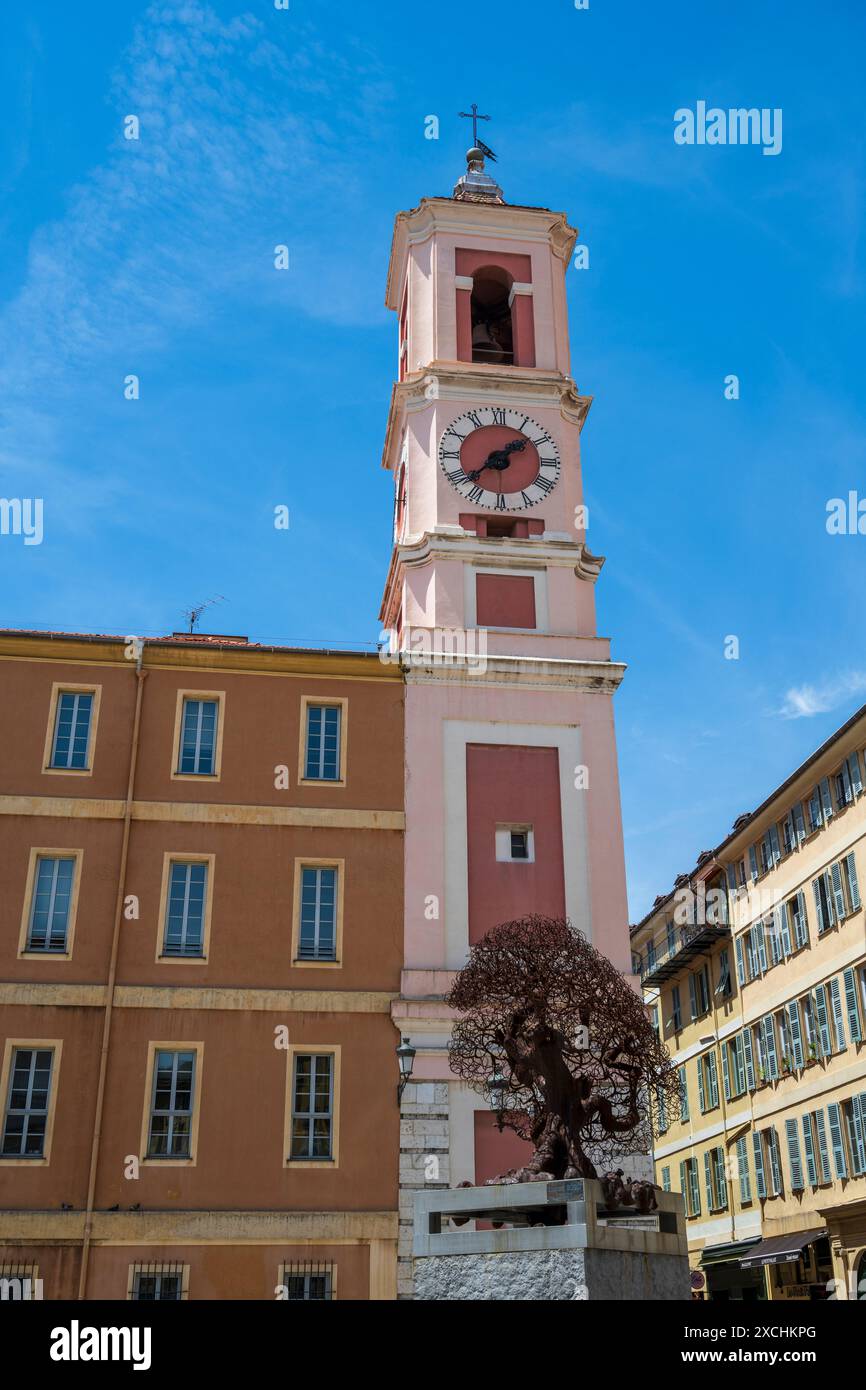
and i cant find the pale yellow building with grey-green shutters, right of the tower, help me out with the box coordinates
[631,706,866,1300]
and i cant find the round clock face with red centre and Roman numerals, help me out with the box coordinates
[439,406,560,512]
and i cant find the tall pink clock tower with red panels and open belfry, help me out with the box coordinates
[381,140,631,1297]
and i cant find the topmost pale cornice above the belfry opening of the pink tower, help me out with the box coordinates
[385,197,577,311]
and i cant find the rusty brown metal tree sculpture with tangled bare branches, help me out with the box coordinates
[448,916,680,1182]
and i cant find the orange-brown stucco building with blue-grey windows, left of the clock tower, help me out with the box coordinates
[0,632,403,1300]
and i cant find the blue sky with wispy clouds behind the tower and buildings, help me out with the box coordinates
[0,0,866,916]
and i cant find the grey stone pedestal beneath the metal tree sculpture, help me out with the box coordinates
[413,1179,691,1301]
